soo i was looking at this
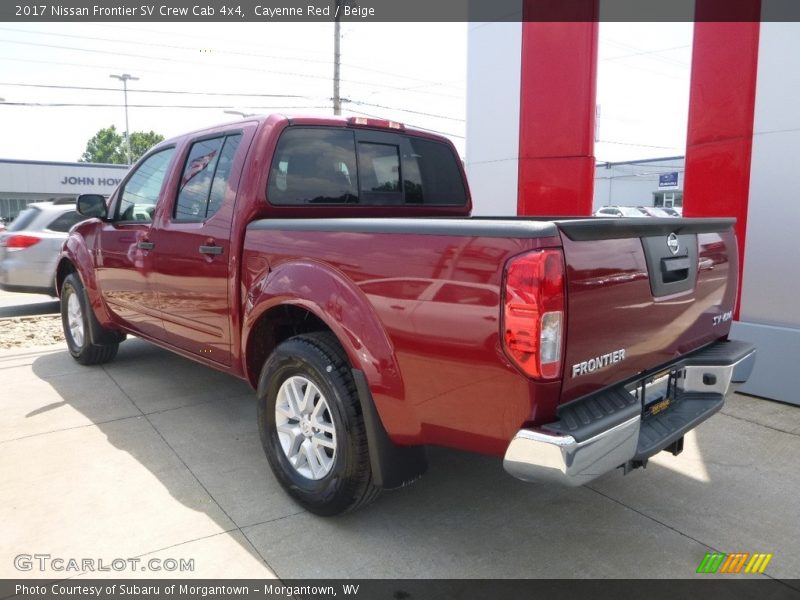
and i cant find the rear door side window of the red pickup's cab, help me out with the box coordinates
[173,134,242,221]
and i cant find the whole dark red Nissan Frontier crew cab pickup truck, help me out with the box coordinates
[55,116,755,515]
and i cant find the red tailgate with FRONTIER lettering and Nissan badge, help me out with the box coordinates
[556,218,738,403]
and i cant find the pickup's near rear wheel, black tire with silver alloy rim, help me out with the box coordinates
[258,333,381,516]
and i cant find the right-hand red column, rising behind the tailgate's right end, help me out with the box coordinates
[683,0,761,318]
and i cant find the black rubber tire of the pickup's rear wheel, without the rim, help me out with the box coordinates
[258,333,381,516]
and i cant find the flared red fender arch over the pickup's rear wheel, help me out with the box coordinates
[242,260,420,443]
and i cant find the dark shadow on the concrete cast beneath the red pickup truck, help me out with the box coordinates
[28,340,797,578]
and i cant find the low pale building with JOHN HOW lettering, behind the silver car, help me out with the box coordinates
[0,159,128,222]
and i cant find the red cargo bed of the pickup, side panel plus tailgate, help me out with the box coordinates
[242,217,737,454]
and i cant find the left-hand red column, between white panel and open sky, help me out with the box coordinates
[517,0,598,215]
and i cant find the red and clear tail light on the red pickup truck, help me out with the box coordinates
[503,249,565,379]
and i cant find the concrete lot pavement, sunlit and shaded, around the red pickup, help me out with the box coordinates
[0,328,800,578]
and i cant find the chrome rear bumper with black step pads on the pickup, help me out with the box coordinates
[503,341,756,486]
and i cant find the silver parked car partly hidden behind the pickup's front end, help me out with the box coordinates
[0,200,86,296]
